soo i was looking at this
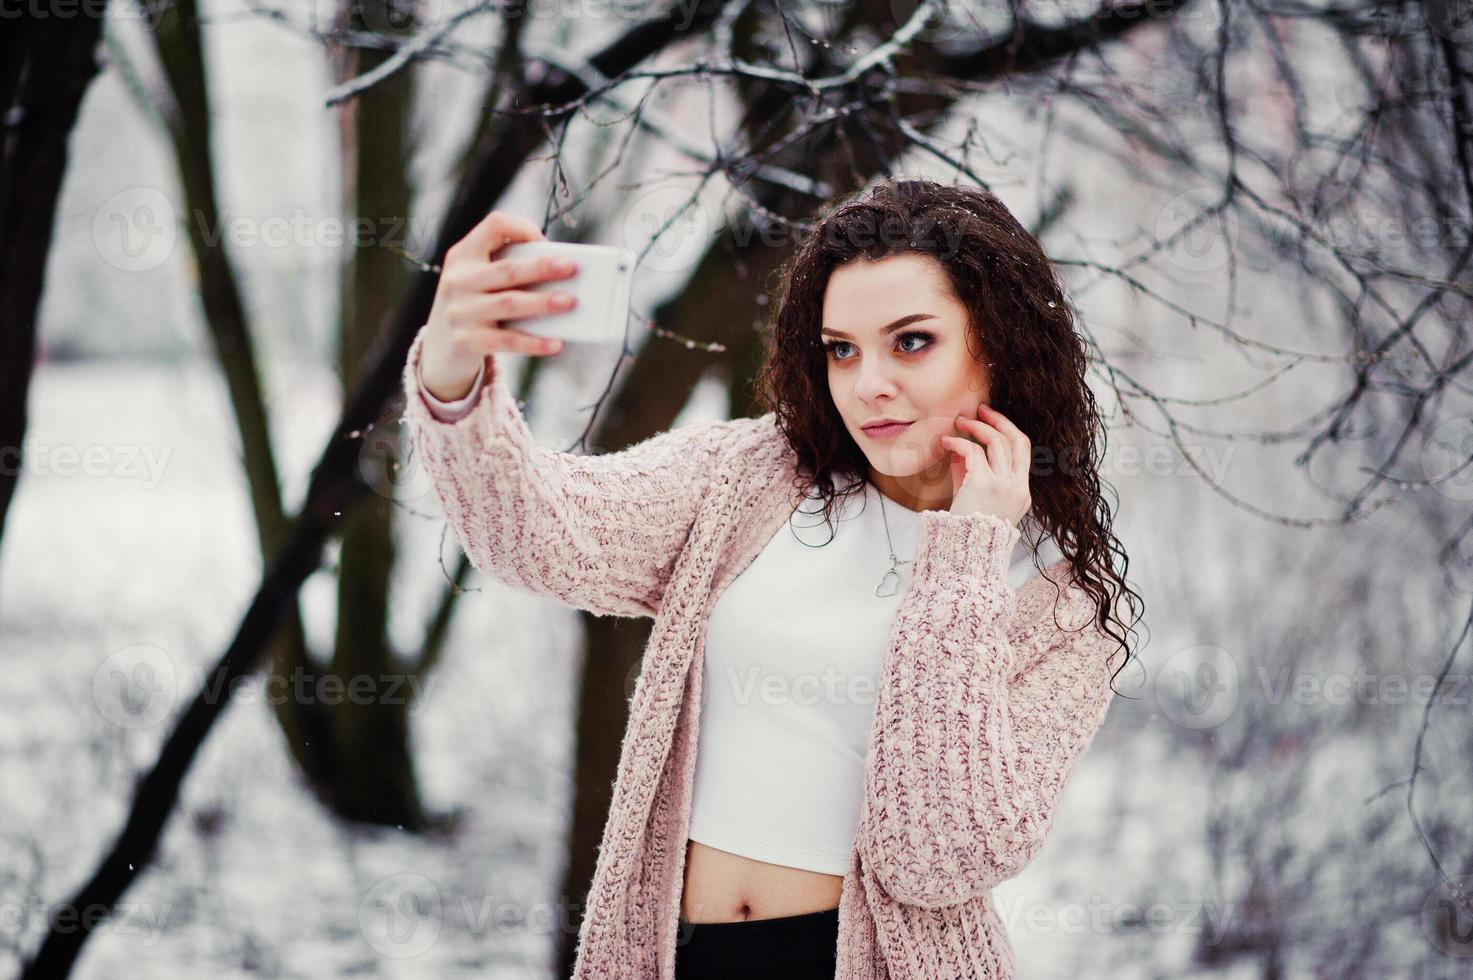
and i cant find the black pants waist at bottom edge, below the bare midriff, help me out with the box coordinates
[675,908,838,980]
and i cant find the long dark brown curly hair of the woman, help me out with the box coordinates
[756,178,1143,686]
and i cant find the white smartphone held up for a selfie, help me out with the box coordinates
[495,242,635,345]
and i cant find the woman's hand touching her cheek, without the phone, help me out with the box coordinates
[941,404,1033,526]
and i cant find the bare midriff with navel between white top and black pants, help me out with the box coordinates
[681,840,844,923]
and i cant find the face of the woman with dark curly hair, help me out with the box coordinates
[820,252,990,510]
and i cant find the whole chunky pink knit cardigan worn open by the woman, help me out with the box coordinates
[404,329,1115,980]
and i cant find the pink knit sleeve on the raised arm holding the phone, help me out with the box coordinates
[404,327,748,616]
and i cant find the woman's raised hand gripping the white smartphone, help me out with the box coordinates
[420,211,577,401]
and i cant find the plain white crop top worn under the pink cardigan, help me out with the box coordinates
[688,482,1064,875]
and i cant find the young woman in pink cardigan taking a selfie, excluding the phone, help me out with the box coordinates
[404,180,1139,980]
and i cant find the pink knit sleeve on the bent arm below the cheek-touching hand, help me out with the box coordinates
[859,510,1115,908]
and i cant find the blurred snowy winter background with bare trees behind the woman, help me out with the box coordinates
[0,0,1473,980]
